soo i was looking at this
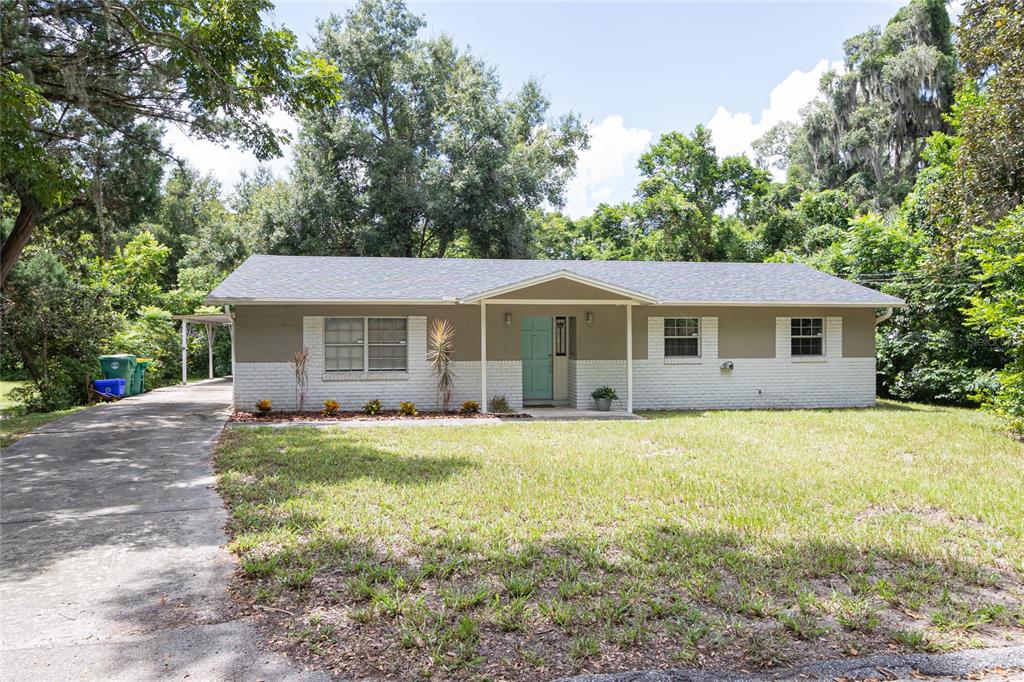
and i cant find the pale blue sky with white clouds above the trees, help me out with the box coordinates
[169,1,921,215]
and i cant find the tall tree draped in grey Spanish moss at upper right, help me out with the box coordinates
[791,0,955,209]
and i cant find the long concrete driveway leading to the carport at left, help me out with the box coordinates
[0,380,321,681]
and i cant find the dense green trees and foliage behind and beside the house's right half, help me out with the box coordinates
[534,0,1024,431]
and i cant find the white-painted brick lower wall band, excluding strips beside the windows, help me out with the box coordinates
[234,357,874,410]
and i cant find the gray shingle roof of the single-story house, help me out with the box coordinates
[207,255,903,306]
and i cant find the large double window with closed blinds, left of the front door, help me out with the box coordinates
[324,317,409,372]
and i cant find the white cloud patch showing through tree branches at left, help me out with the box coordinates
[164,109,299,190]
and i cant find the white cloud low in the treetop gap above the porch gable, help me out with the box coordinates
[564,115,653,218]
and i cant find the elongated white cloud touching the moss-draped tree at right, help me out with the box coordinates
[708,59,843,173]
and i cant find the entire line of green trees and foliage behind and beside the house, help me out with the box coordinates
[2,0,1024,431]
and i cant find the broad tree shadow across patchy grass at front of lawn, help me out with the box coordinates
[216,481,1024,680]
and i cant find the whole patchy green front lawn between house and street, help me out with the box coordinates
[217,403,1024,680]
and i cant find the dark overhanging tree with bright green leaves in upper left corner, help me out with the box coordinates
[0,0,336,285]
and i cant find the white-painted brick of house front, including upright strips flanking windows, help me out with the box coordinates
[234,316,874,411]
